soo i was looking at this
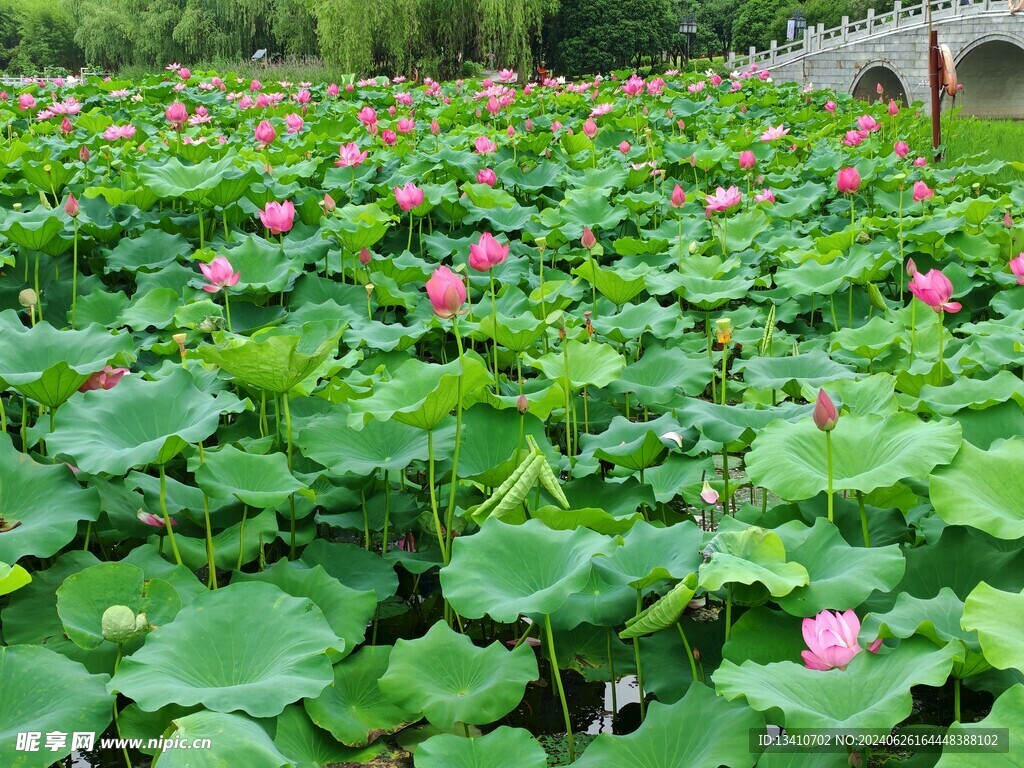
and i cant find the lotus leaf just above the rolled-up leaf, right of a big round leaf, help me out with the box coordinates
[594,520,703,590]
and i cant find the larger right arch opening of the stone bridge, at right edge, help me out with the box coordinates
[956,35,1024,118]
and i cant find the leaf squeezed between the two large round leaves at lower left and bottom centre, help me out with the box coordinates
[303,645,421,746]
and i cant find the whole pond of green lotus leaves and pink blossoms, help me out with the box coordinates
[0,70,1024,768]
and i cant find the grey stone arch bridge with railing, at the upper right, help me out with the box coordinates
[729,0,1024,118]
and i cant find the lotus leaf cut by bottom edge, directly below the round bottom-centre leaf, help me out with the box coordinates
[416,725,548,768]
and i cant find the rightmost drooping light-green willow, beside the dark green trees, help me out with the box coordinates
[479,0,558,74]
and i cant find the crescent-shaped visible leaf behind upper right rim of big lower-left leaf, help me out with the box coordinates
[231,560,377,657]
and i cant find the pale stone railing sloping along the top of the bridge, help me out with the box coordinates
[729,0,1007,69]
